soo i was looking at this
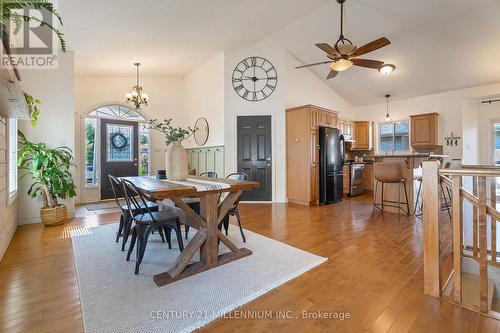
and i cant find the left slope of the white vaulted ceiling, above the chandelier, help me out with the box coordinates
[59,0,328,76]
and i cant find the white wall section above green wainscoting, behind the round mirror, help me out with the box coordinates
[184,52,225,148]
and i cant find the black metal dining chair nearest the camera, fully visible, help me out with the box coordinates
[122,179,184,274]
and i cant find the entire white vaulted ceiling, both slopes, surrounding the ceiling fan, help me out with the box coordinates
[60,0,500,106]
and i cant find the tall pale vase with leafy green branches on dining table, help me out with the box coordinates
[146,119,196,180]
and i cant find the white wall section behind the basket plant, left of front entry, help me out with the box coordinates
[18,52,75,224]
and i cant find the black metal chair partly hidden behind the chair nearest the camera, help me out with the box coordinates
[108,175,165,251]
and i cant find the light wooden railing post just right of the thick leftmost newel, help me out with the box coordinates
[451,176,463,303]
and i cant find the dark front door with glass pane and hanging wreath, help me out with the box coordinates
[101,119,139,200]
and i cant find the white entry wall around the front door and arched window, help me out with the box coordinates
[75,77,185,202]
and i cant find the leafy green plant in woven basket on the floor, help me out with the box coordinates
[18,131,76,226]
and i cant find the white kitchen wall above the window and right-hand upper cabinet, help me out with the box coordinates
[353,83,500,158]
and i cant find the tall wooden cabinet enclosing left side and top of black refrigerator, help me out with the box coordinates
[286,105,338,205]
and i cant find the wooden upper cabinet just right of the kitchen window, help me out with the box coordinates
[410,113,439,148]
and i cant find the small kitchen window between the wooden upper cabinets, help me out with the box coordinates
[378,120,410,153]
